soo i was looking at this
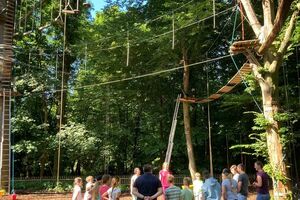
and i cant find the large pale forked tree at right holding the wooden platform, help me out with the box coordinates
[233,0,300,198]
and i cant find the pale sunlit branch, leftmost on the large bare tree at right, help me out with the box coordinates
[240,0,261,37]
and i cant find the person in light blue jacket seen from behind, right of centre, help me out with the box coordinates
[202,170,221,200]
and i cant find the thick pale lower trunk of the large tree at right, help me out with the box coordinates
[260,71,291,199]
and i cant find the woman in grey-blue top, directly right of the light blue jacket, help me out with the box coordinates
[222,168,238,200]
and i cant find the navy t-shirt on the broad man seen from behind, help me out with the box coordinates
[133,172,162,200]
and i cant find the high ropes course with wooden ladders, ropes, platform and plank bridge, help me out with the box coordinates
[0,0,274,195]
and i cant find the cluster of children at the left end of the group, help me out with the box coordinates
[72,175,121,200]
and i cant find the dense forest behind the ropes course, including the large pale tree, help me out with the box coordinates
[11,0,300,197]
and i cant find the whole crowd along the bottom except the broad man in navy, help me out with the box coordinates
[72,162,270,200]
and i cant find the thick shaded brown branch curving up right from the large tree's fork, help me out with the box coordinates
[258,0,293,55]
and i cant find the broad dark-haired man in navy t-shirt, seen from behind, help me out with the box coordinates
[132,164,162,200]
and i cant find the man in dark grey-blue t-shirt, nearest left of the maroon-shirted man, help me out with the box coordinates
[237,164,249,200]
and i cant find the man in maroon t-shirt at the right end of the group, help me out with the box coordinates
[252,161,270,200]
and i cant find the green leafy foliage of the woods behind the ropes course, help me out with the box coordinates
[12,0,299,185]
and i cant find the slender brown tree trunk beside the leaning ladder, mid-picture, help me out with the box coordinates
[182,48,197,179]
